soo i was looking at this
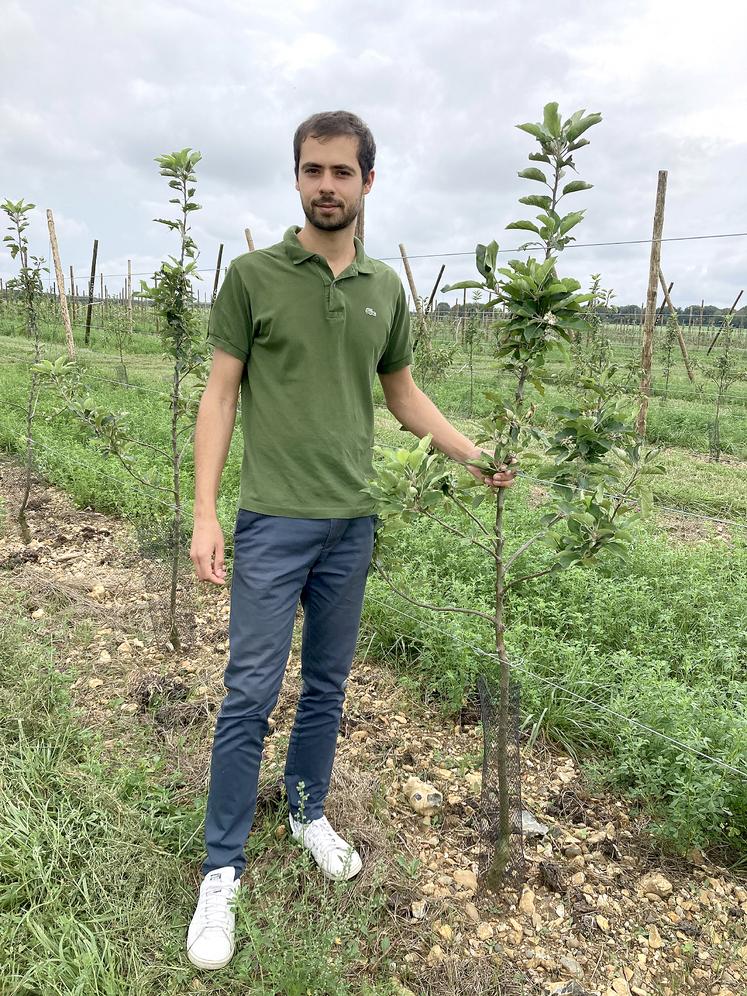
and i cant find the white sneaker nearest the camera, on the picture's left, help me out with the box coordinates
[187,865,241,968]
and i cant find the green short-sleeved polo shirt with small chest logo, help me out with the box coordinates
[207,226,412,519]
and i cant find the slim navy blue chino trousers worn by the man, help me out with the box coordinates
[202,508,376,877]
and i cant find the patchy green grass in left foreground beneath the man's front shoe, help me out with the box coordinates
[0,568,418,996]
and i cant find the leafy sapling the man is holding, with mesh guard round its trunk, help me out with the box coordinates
[365,103,662,891]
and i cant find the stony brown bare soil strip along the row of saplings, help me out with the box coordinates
[0,462,747,996]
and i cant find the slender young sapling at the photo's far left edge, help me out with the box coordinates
[0,198,49,543]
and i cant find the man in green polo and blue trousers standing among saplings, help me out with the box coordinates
[187,111,514,968]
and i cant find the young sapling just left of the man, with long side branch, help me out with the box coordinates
[37,148,208,650]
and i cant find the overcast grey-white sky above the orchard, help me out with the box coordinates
[0,0,747,307]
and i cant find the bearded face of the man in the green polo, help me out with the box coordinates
[296,135,374,232]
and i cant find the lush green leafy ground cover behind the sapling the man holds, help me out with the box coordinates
[364,429,747,855]
